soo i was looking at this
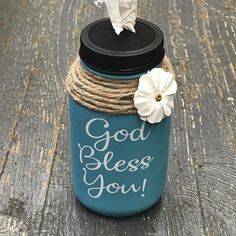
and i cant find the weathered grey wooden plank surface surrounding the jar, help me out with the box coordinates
[0,0,236,236]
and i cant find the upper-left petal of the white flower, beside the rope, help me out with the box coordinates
[138,74,155,97]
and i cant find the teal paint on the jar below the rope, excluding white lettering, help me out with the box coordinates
[69,98,171,217]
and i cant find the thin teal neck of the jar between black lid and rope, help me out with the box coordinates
[80,59,162,80]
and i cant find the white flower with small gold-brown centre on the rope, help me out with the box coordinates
[134,68,177,123]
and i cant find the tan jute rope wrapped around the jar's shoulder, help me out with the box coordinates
[66,57,173,114]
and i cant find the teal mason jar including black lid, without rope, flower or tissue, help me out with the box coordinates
[69,19,171,217]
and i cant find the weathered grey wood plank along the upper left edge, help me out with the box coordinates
[0,1,40,175]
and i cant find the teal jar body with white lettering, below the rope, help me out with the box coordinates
[69,97,171,217]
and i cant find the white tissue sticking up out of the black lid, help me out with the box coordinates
[94,0,138,35]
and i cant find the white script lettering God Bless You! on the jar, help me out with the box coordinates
[77,118,154,198]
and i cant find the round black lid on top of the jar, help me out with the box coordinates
[79,18,165,75]
